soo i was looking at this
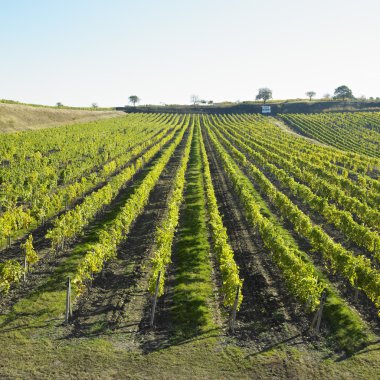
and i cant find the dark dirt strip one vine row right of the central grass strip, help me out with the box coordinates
[204,123,309,349]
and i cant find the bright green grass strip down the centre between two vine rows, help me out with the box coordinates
[171,124,216,337]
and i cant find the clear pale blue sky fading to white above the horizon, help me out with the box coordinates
[0,0,380,106]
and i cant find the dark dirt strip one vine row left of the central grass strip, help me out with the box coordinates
[68,127,188,349]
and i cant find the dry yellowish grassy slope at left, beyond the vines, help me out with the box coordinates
[0,103,125,133]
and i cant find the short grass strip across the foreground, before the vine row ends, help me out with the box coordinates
[0,321,380,379]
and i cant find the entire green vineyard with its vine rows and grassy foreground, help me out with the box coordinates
[0,112,380,379]
